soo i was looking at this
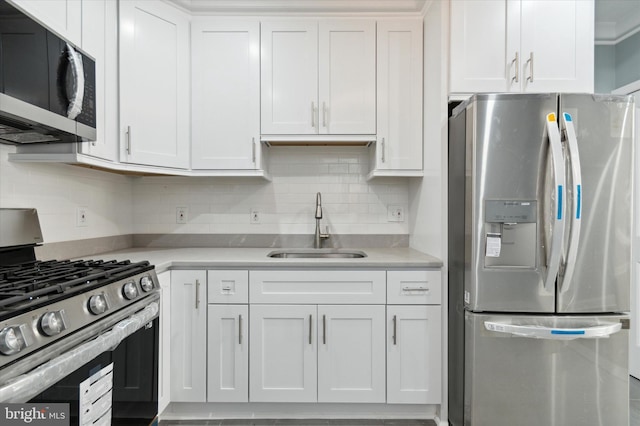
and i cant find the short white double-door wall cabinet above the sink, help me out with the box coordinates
[261,19,376,135]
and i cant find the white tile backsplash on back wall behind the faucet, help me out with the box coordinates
[133,147,409,234]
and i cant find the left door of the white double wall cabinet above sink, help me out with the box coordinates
[260,19,318,134]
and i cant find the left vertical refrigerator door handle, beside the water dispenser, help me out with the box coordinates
[544,113,565,292]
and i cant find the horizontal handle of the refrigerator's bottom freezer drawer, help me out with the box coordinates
[484,321,622,340]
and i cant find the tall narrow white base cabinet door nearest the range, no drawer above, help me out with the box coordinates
[170,271,207,402]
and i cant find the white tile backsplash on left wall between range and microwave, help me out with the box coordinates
[0,144,133,243]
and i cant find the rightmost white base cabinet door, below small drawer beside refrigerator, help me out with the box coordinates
[387,305,442,404]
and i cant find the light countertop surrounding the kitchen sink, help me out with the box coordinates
[91,247,442,273]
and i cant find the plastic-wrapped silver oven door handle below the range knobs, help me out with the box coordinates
[0,302,159,403]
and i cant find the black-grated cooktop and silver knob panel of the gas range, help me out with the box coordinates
[0,260,159,368]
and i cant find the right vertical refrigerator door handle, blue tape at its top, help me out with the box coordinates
[560,112,584,293]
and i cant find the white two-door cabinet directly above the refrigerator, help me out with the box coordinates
[449,0,595,93]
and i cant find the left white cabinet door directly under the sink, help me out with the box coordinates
[249,305,318,402]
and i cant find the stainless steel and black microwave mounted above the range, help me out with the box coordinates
[0,0,96,144]
